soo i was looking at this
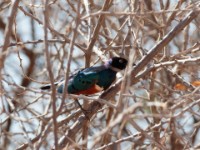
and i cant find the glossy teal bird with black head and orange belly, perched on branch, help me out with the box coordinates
[41,57,128,118]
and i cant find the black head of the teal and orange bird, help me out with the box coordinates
[109,57,128,70]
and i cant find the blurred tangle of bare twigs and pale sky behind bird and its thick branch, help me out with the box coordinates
[0,0,200,150]
